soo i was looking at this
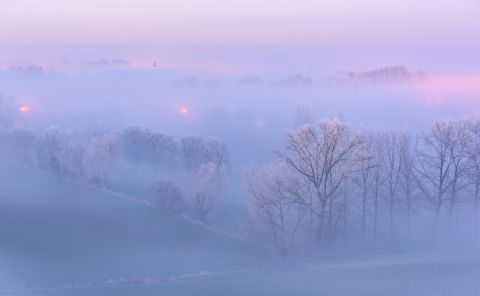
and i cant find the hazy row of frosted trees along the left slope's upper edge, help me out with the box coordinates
[0,127,229,223]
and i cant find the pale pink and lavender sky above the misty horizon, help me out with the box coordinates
[0,0,480,74]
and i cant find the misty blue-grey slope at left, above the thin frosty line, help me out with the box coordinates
[0,166,268,286]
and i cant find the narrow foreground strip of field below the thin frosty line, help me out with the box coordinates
[4,258,480,296]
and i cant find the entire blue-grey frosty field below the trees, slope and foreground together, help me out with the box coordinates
[0,164,480,296]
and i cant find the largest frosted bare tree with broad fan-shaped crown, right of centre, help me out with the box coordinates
[279,120,362,246]
